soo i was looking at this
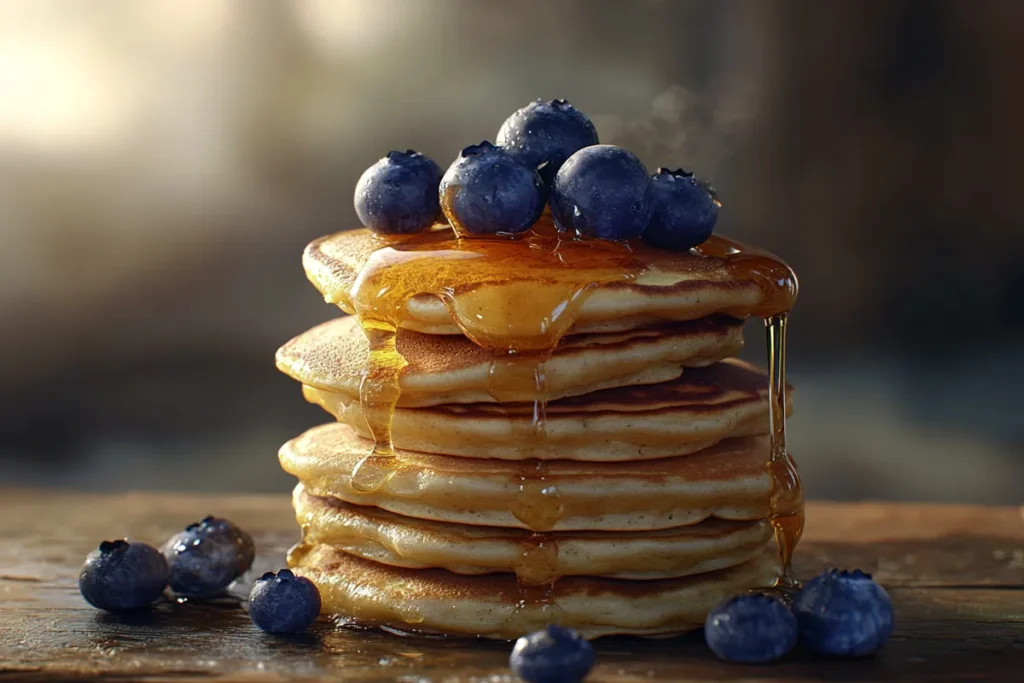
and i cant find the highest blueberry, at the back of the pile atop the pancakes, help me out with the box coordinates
[496,99,598,187]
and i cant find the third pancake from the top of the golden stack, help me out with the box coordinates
[303,359,793,462]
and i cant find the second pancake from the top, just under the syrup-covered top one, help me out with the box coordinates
[276,316,743,407]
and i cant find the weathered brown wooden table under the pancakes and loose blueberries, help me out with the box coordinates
[0,490,1024,683]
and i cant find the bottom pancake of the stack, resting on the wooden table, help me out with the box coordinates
[289,546,779,639]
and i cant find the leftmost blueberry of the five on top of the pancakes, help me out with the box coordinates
[355,150,441,234]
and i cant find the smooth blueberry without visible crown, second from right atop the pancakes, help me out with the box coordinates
[551,144,653,240]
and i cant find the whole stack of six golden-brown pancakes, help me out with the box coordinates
[276,230,788,638]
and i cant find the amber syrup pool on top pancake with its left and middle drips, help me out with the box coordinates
[348,218,643,495]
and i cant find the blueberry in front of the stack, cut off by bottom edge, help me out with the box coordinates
[509,626,594,683]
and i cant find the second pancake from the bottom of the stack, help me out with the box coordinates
[292,484,774,584]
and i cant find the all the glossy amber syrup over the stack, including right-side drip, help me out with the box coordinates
[319,211,803,626]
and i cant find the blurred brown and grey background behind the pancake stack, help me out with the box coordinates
[0,0,1024,503]
